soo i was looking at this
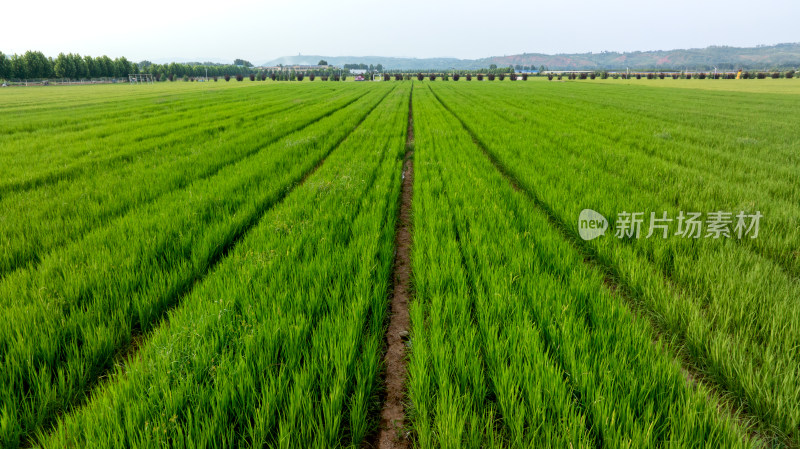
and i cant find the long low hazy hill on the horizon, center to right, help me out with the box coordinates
[264,43,800,70]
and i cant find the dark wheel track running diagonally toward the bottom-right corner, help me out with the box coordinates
[429,86,784,448]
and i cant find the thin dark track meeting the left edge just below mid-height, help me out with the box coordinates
[0,94,366,282]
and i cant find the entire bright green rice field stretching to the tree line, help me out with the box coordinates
[0,77,800,448]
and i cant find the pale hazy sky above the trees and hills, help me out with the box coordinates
[0,0,800,64]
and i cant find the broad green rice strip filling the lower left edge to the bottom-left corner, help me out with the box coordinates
[0,82,391,447]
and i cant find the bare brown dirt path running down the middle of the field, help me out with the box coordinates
[377,87,414,449]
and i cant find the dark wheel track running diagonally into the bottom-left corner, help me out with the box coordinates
[19,89,393,449]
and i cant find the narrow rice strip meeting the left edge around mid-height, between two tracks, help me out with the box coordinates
[0,84,360,278]
